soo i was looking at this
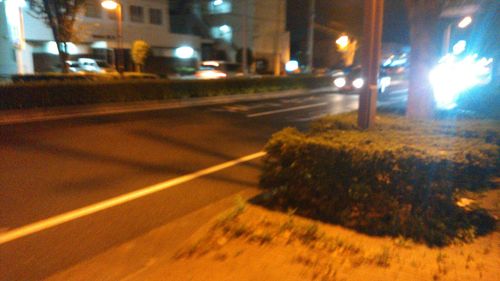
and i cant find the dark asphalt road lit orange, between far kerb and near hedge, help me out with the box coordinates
[0,86,406,280]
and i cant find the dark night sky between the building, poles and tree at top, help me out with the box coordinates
[288,0,409,56]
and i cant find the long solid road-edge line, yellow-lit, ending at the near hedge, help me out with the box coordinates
[0,151,266,245]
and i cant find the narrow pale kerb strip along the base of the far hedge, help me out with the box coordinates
[0,88,331,125]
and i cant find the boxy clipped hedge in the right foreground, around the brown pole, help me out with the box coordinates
[261,114,500,245]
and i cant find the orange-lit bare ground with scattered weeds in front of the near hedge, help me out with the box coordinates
[143,190,500,281]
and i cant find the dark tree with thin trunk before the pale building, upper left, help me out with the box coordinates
[29,0,85,73]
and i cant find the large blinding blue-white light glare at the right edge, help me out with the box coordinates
[429,55,492,109]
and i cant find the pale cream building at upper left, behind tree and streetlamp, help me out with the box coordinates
[0,0,203,75]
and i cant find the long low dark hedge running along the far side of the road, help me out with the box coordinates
[0,76,331,109]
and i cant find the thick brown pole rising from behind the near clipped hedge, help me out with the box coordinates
[358,0,384,129]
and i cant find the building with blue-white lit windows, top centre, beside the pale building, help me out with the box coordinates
[170,0,290,74]
